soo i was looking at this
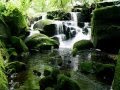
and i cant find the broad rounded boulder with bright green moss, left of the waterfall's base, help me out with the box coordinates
[25,34,59,50]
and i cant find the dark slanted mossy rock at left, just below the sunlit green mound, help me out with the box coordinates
[11,36,28,54]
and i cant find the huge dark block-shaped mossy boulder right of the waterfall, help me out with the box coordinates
[92,6,120,53]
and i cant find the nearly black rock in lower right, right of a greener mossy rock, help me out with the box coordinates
[93,63,115,85]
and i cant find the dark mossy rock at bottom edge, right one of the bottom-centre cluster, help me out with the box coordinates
[55,75,80,90]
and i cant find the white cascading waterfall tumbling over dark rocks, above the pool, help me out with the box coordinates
[54,12,91,49]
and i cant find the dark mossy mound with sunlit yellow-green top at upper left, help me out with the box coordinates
[2,3,27,36]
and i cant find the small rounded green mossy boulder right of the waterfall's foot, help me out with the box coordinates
[72,40,93,55]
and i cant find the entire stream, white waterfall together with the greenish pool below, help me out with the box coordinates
[10,12,110,90]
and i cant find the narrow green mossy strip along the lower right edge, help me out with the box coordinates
[112,55,120,90]
